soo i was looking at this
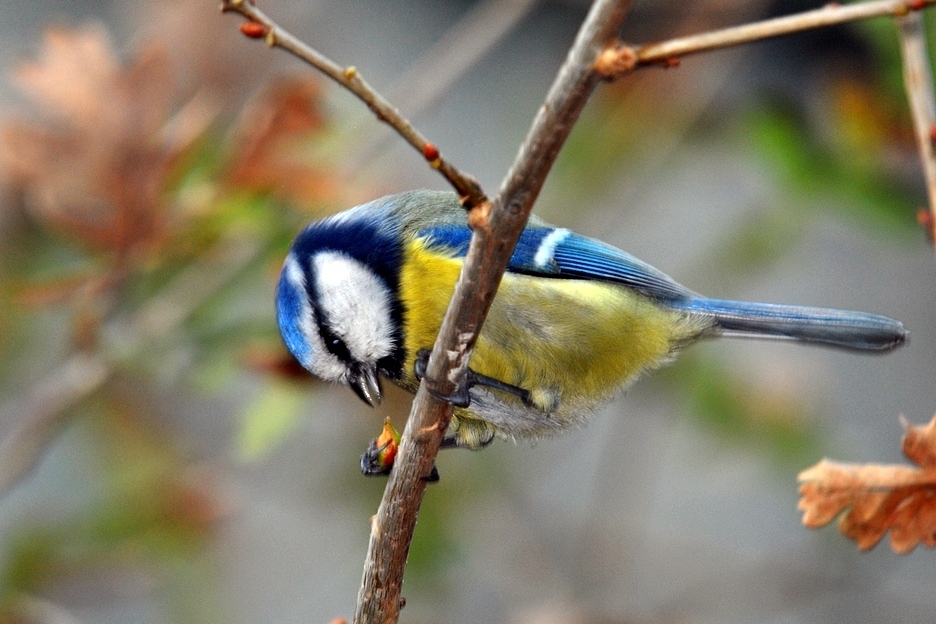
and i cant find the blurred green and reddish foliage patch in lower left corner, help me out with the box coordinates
[0,408,219,622]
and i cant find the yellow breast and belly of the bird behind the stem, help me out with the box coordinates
[400,240,706,418]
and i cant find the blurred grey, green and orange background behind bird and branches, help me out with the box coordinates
[0,0,936,624]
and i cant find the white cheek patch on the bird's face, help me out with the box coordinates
[310,251,394,364]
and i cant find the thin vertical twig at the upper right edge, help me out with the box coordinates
[897,13,936,246]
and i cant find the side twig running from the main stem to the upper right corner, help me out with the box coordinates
[599,0,936,80]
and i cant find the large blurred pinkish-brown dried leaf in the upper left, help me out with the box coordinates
[0,27,212,258]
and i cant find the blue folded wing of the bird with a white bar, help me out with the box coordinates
[419,225,695,302]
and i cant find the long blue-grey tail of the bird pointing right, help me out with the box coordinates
[669,297,907,351]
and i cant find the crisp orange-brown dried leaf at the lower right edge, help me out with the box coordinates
[798,416,936,553]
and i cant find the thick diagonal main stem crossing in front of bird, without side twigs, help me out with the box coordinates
[354,0,630,624]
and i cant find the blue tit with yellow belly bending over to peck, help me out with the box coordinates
[276,191,906,449]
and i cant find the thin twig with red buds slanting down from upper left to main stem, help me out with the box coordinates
[221,0,487,207]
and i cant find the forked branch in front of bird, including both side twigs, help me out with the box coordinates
[214,0,936,623]
